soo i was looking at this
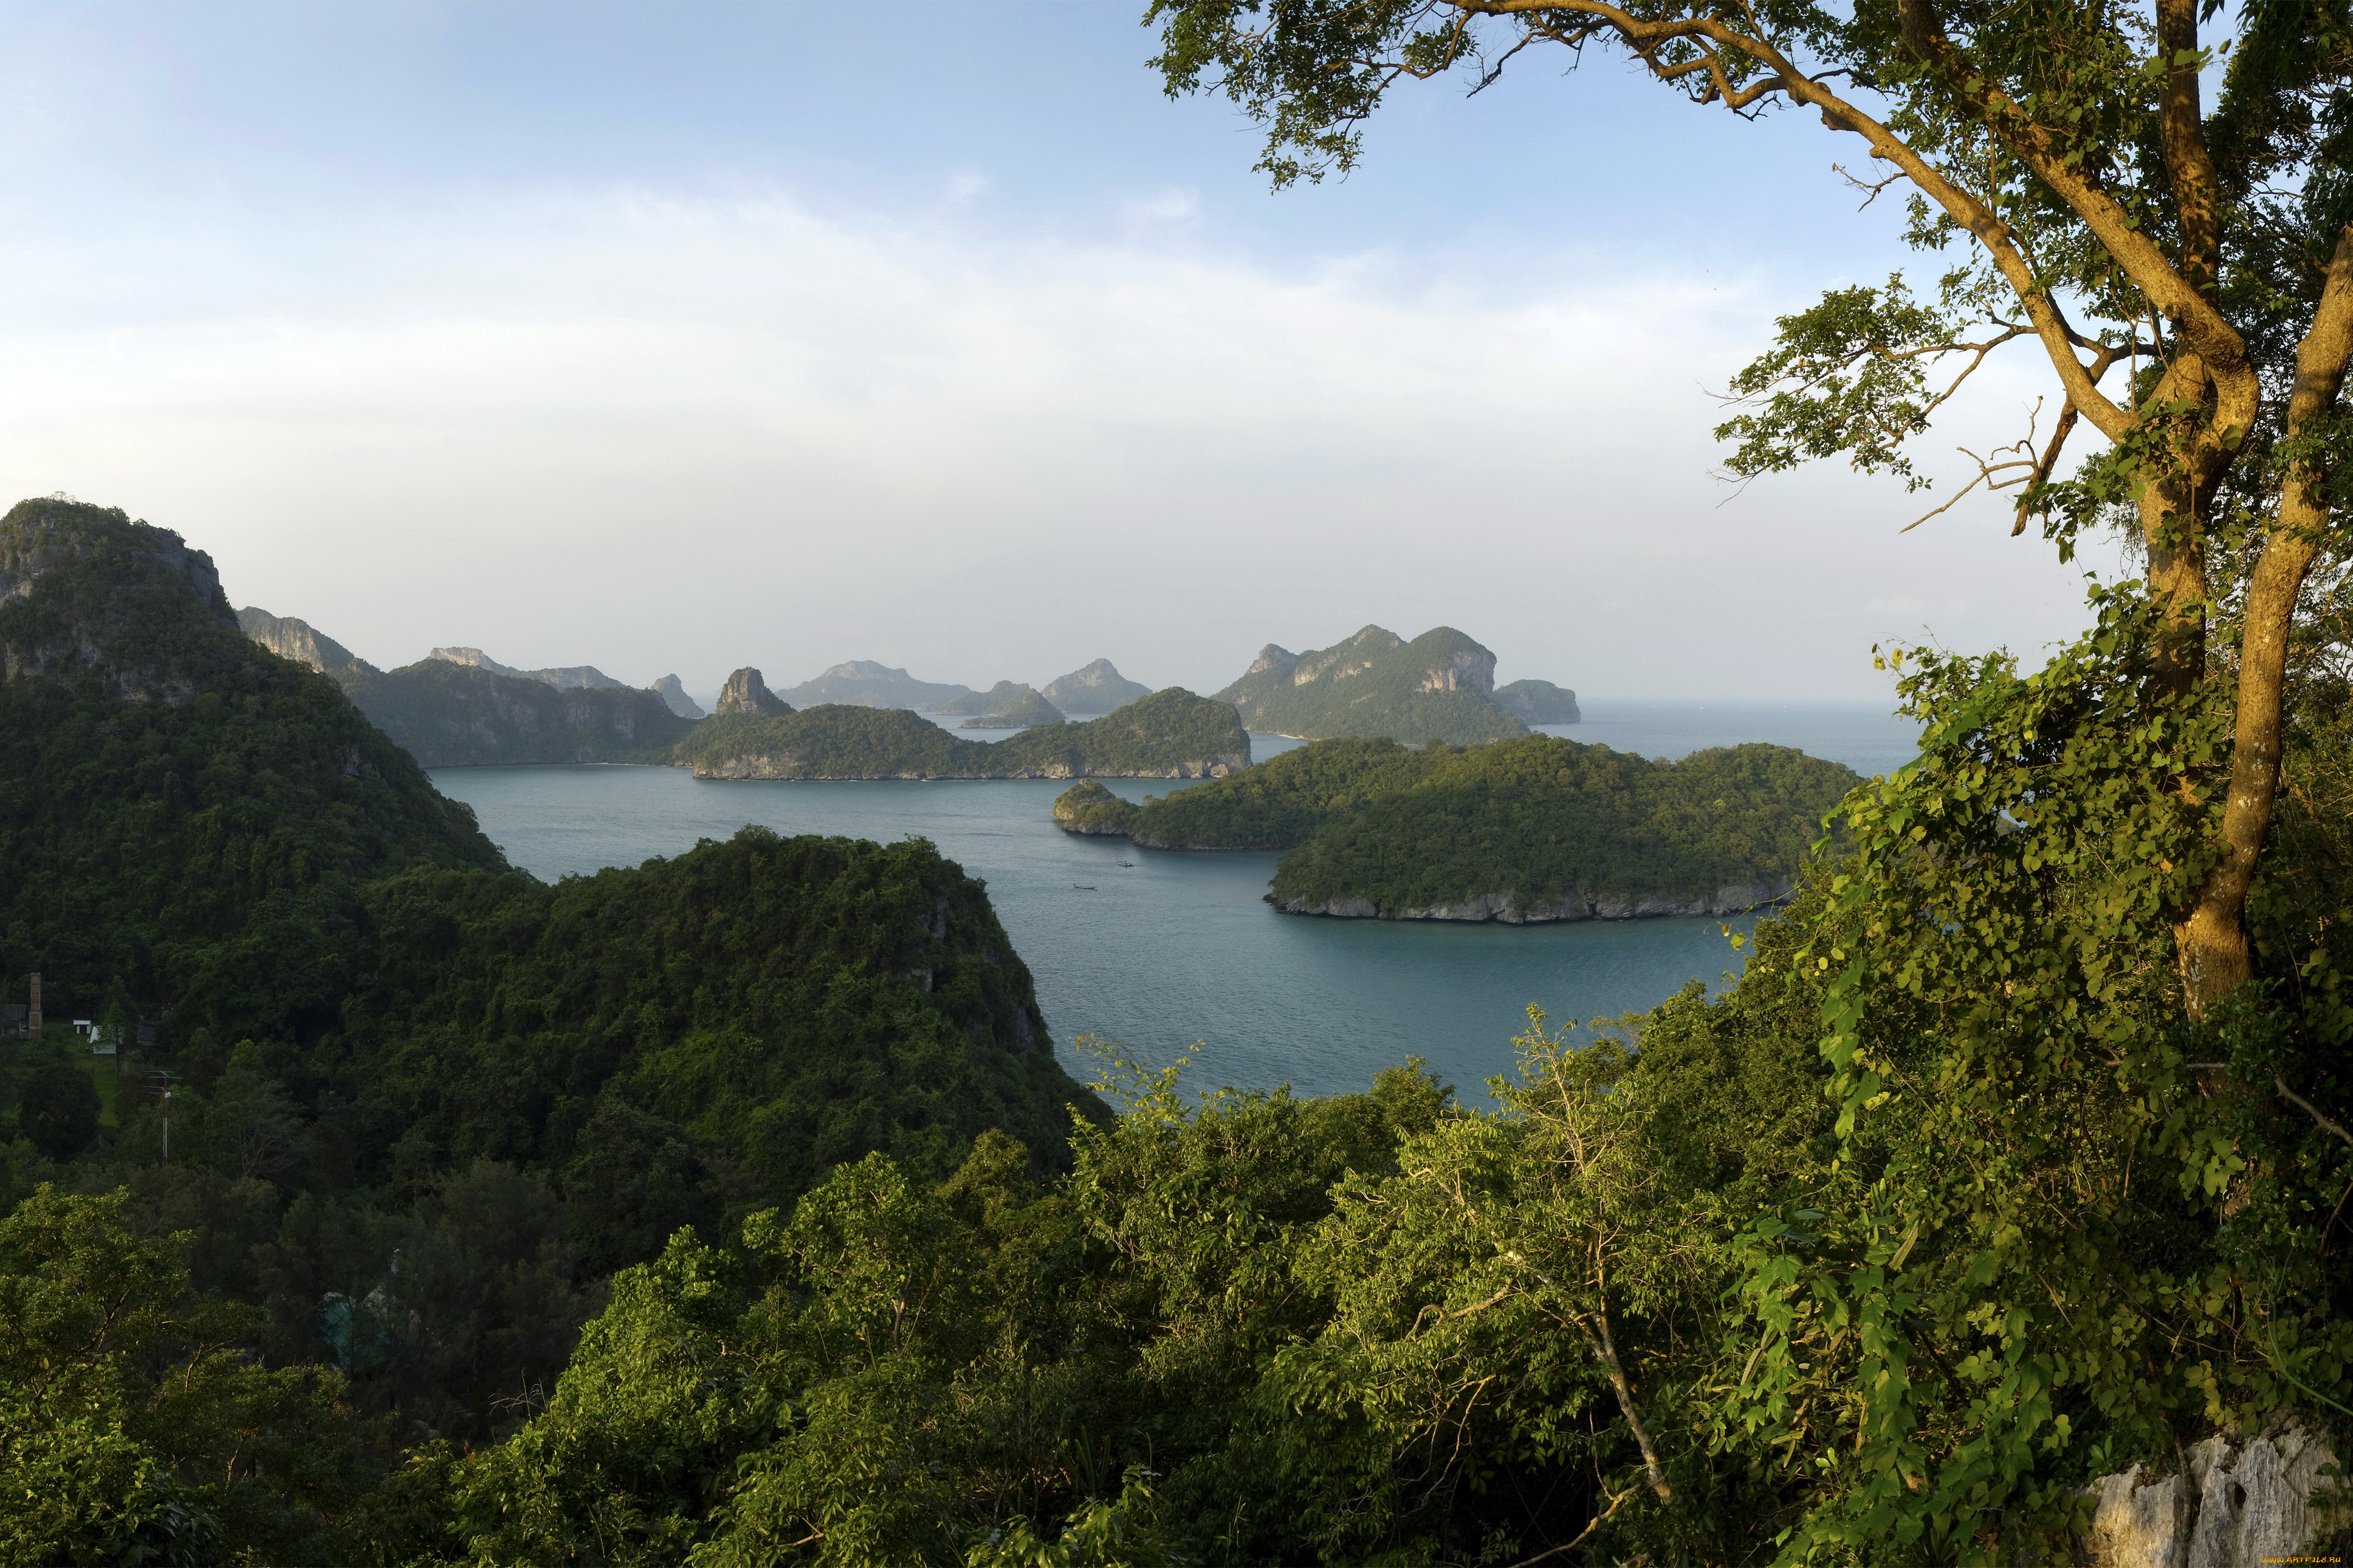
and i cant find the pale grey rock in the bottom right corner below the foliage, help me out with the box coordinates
[2083,1427,2348,1568]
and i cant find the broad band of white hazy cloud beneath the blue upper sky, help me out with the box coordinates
[0,176,2117,696]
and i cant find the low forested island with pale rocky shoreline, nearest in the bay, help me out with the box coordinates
[1054,736,1861,924]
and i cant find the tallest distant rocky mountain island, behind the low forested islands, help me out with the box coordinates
[1217,625,1527,745]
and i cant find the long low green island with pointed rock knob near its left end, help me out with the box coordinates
[673,686,1249,778]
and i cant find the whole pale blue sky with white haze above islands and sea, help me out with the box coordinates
[0,0,2127,698]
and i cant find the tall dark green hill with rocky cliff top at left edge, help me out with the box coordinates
[0,501,501,1039]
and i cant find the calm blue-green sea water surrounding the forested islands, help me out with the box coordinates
[433,700,1918,1105]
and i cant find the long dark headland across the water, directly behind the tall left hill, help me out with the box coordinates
[337,658,694,769]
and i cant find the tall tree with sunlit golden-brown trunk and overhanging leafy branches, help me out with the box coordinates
[1149,0,2353,1013]
